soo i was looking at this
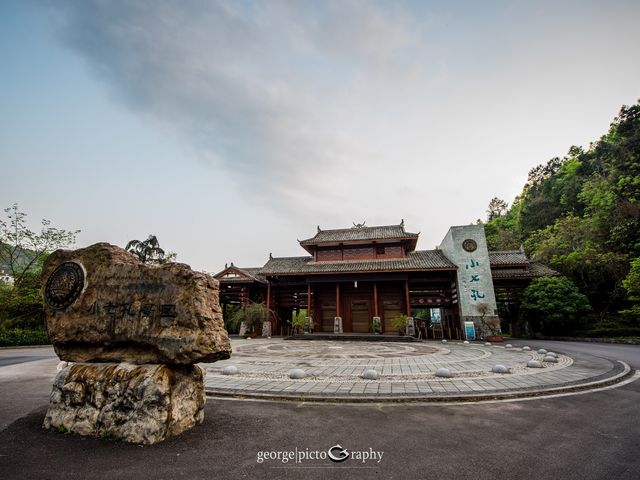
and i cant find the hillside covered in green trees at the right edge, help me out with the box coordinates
[485,101,640,326]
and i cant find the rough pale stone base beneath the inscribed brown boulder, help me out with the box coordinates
[43,363,205,444]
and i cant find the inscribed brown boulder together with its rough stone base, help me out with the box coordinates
[41,243,231,444]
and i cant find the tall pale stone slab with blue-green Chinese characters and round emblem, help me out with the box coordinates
[439,225,500,335]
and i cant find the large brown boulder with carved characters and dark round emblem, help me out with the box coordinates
[41,243,231,365]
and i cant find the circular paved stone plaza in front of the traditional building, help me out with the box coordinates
[202,338,633,402]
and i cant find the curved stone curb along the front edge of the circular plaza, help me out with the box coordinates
[205,360,635,403]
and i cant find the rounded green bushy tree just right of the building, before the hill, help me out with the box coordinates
[520,277,591,335]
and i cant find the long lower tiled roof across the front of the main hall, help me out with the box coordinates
[260,250,456,275]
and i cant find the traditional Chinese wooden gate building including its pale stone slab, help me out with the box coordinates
[216,221,556,338]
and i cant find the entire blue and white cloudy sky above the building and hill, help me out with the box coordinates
[0,0,640,272]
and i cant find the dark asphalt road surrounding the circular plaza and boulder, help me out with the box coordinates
[0,342,640,480]
